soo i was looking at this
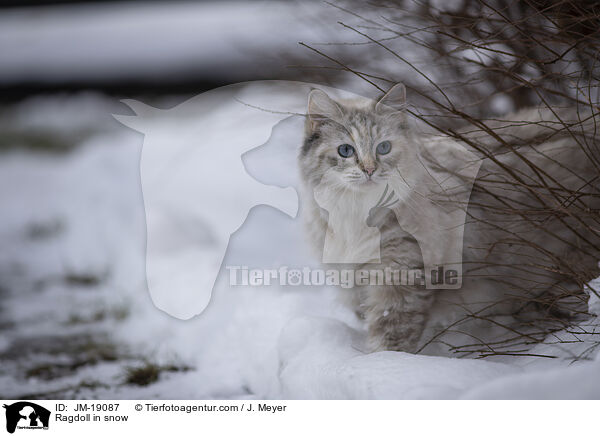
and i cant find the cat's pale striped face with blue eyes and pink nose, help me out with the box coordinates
[300,85,409,190]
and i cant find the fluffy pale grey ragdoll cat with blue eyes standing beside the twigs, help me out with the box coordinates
[298,84,600,353]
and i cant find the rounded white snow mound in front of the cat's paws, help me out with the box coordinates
[279,318,520,399]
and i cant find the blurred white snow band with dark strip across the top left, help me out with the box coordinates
[0,1,360,102]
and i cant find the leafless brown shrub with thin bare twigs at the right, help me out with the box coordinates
[306,0,600,359]
